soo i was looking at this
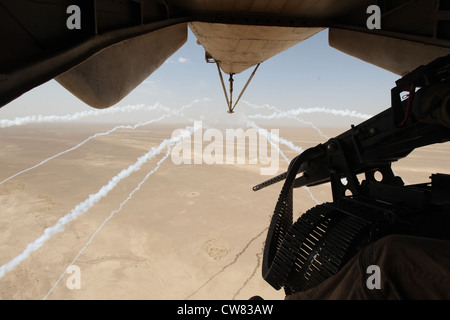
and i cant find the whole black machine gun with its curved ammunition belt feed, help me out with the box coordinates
[253,56,450,294]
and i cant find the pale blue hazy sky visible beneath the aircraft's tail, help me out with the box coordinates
[0,30,399,126]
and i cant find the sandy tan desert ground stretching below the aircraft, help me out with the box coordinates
[0,123,450,300]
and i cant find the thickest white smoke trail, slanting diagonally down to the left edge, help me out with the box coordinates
[0,123,198,279]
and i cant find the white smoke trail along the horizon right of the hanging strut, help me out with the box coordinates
[243,102,372,120]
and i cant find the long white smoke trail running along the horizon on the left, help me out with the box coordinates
[0,98,209,128]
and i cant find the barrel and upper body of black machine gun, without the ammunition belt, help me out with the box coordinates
[253,55,450,201]
